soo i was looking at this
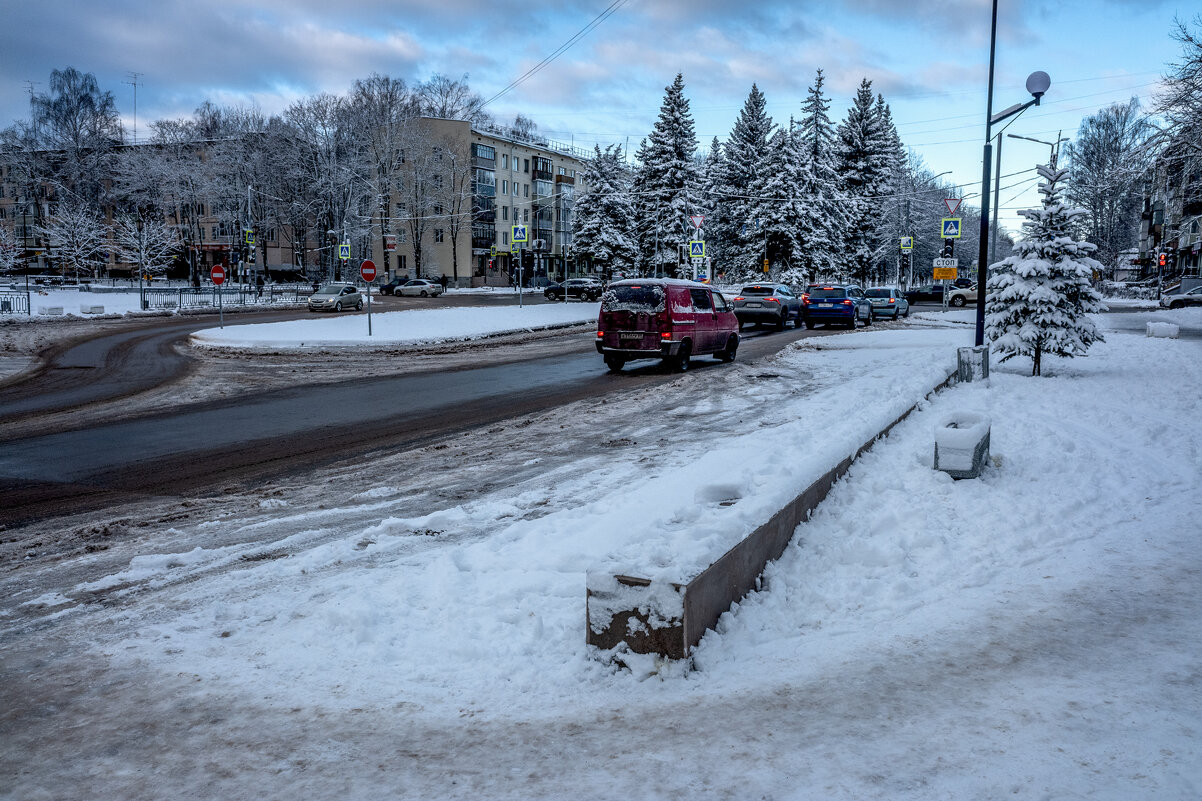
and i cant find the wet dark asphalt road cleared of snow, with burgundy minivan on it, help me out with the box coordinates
[0,296,835,527]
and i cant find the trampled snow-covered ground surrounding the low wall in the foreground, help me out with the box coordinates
[0,304,1202,800]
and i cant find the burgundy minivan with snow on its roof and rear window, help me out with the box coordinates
[597,278,739,372]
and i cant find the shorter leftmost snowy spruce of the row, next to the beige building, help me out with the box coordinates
[572,144,638,274]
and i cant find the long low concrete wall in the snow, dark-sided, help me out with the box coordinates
[585,373,956,659]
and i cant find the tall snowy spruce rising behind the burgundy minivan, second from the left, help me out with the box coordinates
[635,73,697,273]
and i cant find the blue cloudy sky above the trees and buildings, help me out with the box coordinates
[0,0,1182,227]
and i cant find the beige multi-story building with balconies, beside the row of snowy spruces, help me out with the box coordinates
[373,118,588,286]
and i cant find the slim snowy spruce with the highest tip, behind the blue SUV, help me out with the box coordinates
[797,70,844,277]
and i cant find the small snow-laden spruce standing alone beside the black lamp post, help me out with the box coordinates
[984,162,1106,375]
